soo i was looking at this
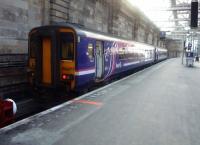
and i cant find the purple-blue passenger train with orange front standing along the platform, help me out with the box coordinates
[28,23,167,91]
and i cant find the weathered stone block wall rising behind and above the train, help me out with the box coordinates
[0,0,163,54]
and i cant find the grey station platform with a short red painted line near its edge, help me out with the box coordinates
[0,59,200,145]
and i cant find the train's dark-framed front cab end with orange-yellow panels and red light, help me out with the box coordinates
[28,26,76,90]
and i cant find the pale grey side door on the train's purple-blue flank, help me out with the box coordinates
[95,41,104,79]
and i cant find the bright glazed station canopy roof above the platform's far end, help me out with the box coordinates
[128,0,199,39]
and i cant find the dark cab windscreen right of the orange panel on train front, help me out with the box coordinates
[60,32,74,60]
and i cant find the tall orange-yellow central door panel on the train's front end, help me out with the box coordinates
[42,38,52,84]
